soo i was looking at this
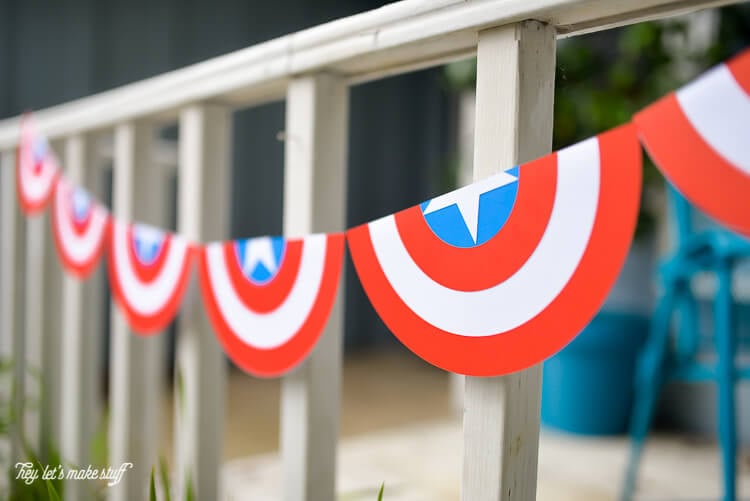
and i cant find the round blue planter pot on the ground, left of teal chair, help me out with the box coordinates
[541,312,649,435]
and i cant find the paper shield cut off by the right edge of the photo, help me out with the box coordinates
[634,47,750,235]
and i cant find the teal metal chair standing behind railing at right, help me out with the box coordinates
[621,186,750,501]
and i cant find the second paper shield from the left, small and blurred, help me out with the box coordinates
[52,178,109,278]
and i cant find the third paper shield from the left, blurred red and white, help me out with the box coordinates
[109,220,196,334]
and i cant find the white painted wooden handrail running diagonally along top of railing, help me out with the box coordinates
[0,0,733,149]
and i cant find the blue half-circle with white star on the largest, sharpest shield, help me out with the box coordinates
[420,167,518,248]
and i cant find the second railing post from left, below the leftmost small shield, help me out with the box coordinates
[23,145,62,461]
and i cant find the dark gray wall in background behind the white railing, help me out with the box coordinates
[0,0,462,348]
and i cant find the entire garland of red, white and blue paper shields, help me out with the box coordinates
[7,47,750,377]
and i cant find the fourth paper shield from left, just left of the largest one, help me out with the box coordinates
[200,234,344,377]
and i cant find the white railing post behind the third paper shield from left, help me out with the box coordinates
[108,122,167,501]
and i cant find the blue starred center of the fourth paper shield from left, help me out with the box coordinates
[234,237,286,285]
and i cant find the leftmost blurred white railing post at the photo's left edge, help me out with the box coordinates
[0,147,26,464]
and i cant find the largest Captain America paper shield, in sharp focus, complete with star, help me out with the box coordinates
[347,125,642,376]
